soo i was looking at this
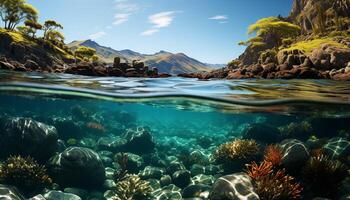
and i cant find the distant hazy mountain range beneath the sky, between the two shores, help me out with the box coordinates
[68,40,222,74]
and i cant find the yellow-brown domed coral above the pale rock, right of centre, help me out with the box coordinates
[213,140,259,163]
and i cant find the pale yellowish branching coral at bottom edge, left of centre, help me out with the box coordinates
[112,175,152,200]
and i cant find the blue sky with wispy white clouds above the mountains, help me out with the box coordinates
[28,0,292,64]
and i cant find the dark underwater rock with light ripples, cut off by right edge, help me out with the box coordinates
[322,137,350,159]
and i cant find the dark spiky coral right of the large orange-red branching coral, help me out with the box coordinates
[303,154,348,198]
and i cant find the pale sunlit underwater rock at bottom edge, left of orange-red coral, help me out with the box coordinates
[209,173,259,200]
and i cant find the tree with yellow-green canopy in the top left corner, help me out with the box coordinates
[0,0,38,30]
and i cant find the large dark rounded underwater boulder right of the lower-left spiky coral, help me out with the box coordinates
[48,147,105,188]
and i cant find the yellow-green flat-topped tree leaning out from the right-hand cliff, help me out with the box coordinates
[239,17,301,48]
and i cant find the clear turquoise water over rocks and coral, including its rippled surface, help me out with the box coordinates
[0,72,350,199]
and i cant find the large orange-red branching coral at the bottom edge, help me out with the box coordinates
[247,161,302,200]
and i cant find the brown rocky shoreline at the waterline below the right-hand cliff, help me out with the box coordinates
[179,44,350,81]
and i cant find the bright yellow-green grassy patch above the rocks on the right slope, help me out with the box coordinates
[282,37,348,53]
